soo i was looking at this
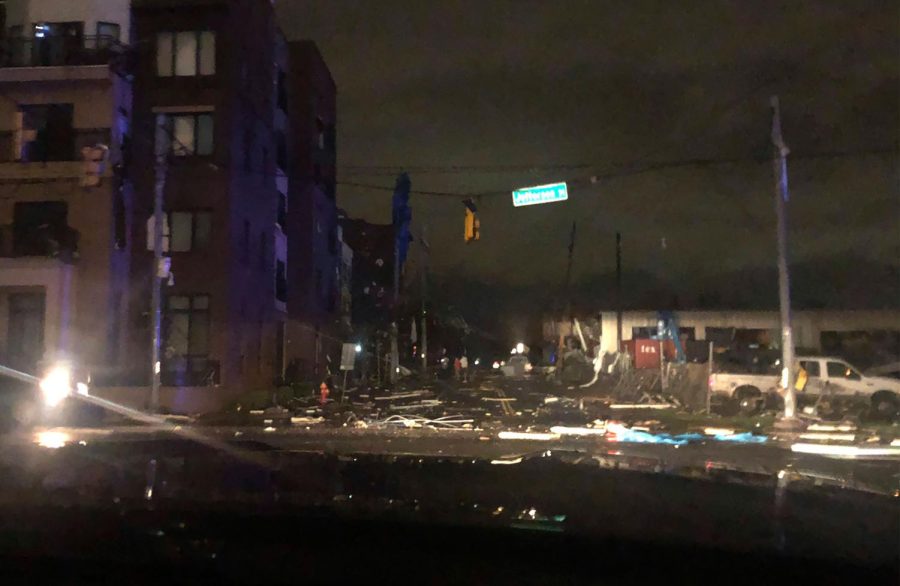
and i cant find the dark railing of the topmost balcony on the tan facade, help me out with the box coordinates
[0,35,121,67]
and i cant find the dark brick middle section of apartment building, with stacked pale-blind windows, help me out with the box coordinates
[130,0,285,395]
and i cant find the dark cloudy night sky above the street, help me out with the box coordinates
[277,0,900,298]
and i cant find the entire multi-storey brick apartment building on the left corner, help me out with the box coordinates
[0,0,341,411]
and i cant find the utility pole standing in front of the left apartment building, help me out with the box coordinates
[150,114,171,412]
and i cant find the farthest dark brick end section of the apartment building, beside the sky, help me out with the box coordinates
[286,41,342,378]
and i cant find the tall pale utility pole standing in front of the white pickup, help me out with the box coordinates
[770,96,797,425]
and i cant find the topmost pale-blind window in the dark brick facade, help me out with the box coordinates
[156,31,216,77]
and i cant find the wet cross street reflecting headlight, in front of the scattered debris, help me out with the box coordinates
[2,425,900,495]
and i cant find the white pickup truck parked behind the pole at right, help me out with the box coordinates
[709,356,900,420]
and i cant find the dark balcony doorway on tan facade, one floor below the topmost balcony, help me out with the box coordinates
[17,104,75,162]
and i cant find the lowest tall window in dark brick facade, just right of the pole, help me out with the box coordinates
[164,295,210,385]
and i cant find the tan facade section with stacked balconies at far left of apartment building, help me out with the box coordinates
[0,0,133,380]
